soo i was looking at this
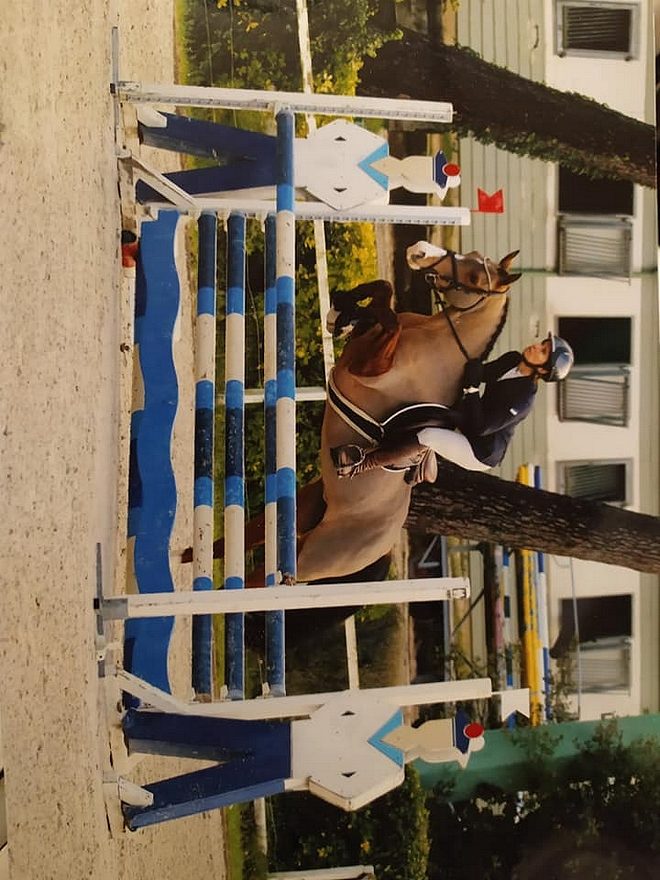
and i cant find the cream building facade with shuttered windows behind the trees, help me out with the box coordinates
[446,0,660,719]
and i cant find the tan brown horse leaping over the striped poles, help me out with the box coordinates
[193,242,521,585]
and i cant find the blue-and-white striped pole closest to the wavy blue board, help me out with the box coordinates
[192,213,218,695]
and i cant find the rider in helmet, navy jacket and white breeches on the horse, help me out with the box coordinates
[332,332,574,482]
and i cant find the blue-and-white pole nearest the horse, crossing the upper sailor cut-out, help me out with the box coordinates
[275,110,296,592]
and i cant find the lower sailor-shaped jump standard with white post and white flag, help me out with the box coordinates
[117,679,529,829]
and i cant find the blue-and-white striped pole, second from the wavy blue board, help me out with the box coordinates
[224,214,245,700]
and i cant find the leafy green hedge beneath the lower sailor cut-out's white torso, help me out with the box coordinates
[269,767,428,880]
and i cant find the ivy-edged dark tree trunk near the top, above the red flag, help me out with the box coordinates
[358,30,656,187]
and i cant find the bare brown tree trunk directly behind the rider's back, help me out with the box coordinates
[406,461,660,574]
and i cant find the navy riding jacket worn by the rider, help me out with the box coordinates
[458,351,536,467]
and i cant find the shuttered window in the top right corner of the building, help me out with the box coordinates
[556,0,639,61]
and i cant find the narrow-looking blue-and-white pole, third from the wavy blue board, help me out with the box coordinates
[264,214,286,696]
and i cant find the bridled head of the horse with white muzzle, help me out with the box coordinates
[406,241,521,311]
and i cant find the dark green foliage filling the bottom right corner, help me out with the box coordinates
[429,722,660,880]
